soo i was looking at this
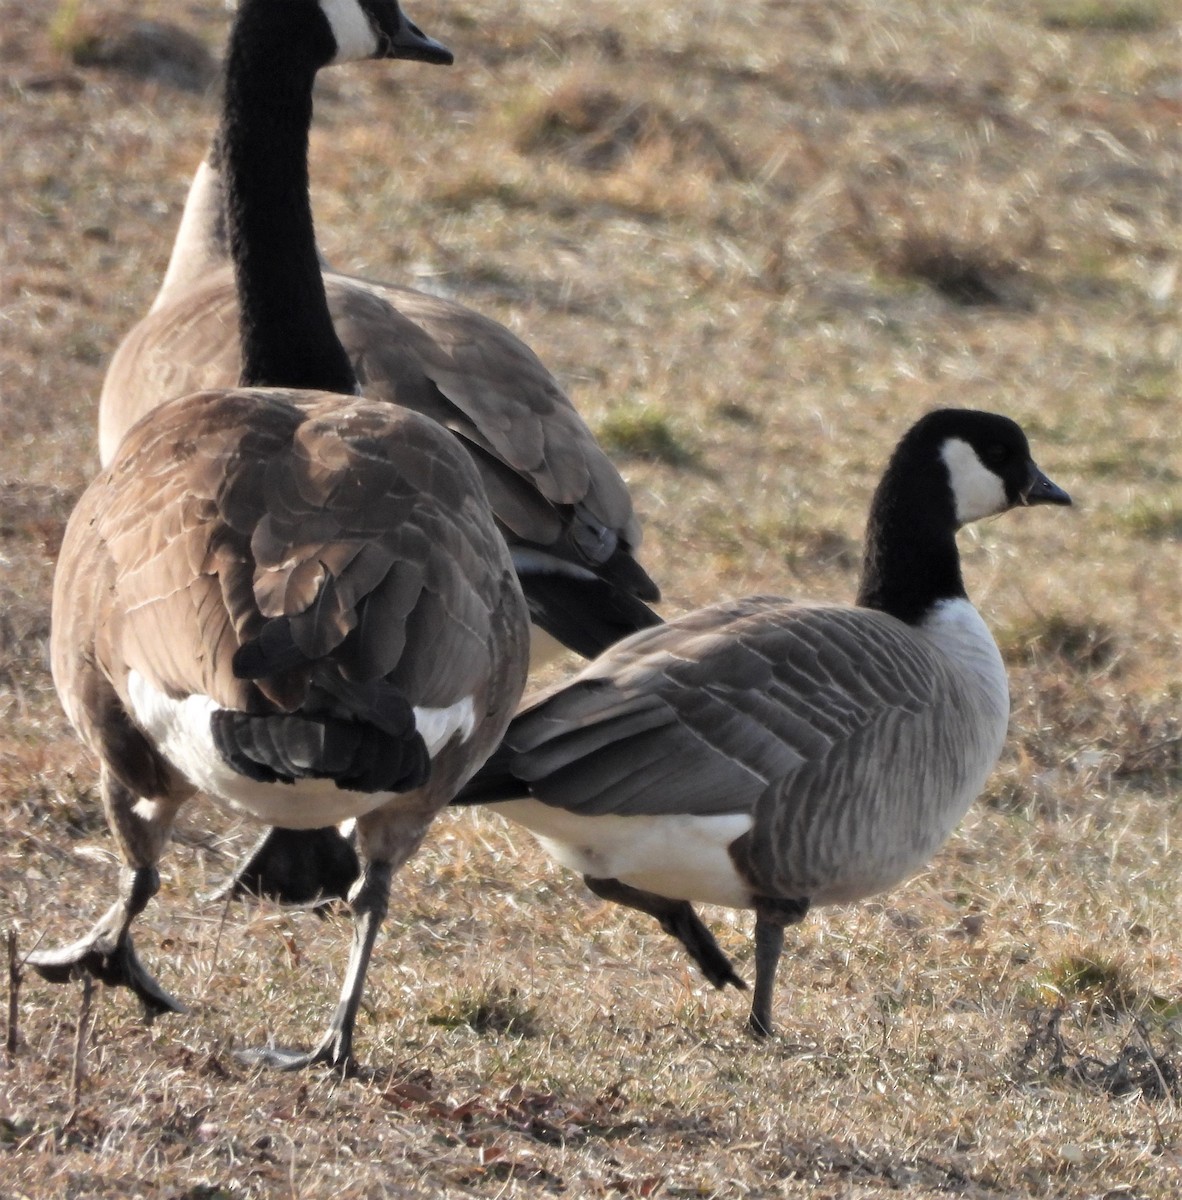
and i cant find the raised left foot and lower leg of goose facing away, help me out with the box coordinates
[28,866,185,1019]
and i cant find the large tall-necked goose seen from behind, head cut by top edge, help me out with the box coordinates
[29,0,529,1072]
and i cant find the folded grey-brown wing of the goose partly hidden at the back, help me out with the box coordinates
[336,275,660,628]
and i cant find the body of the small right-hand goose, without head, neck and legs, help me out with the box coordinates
[497,598,1009,908]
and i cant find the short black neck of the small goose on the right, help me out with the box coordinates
[857,457,966,625]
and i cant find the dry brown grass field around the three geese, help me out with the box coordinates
[0,0,1182,1200]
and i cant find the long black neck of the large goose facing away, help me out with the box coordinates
[218,2,356,392]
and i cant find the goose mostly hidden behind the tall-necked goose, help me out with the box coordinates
[98,88,660,664]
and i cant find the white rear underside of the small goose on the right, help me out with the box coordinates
[490,799,751,908]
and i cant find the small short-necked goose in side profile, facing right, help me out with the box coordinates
[455,409,1070,1036]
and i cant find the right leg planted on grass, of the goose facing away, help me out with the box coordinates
[236,862,394,1074]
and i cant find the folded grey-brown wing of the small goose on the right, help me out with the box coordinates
[498,598,935,815]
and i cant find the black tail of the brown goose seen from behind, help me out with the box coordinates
[210,709,431,792]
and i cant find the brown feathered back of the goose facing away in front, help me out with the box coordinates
[54,389,524,787]
